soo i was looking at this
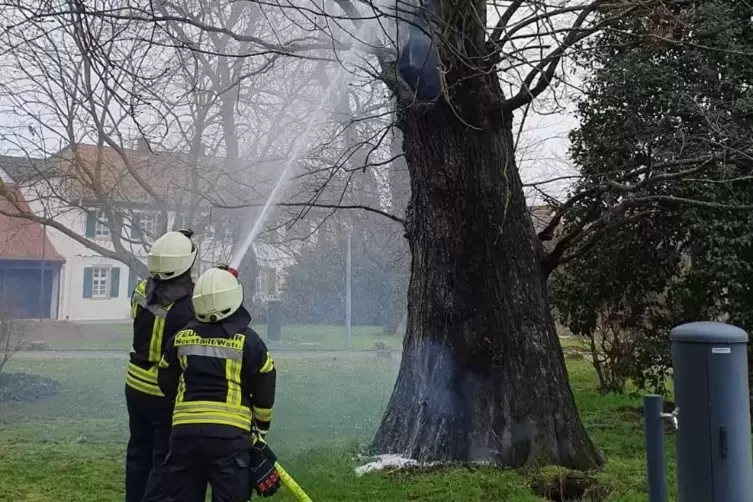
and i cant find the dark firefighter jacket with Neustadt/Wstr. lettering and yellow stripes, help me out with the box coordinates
[158,307,276,431]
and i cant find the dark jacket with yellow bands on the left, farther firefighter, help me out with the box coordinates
[126,274,193,397]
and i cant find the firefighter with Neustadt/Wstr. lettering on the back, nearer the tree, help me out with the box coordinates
[158,267,280,502]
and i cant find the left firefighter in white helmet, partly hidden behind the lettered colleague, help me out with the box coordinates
[125,230,196,502]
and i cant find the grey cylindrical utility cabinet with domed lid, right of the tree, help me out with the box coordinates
[671,322,753,502]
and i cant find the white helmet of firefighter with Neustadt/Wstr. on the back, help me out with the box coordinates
[192,267,243,322]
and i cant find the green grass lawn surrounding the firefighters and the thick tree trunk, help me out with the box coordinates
[0,353,674,502]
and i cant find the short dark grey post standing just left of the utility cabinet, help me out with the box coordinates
[643,394,667,502]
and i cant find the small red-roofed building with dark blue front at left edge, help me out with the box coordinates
[0,157,65,319]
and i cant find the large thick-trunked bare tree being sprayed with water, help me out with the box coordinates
[4,0,748,469]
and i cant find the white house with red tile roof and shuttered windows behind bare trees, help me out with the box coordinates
[0,141,306,321]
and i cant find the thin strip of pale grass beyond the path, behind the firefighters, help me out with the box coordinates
[39,322,403,350]
